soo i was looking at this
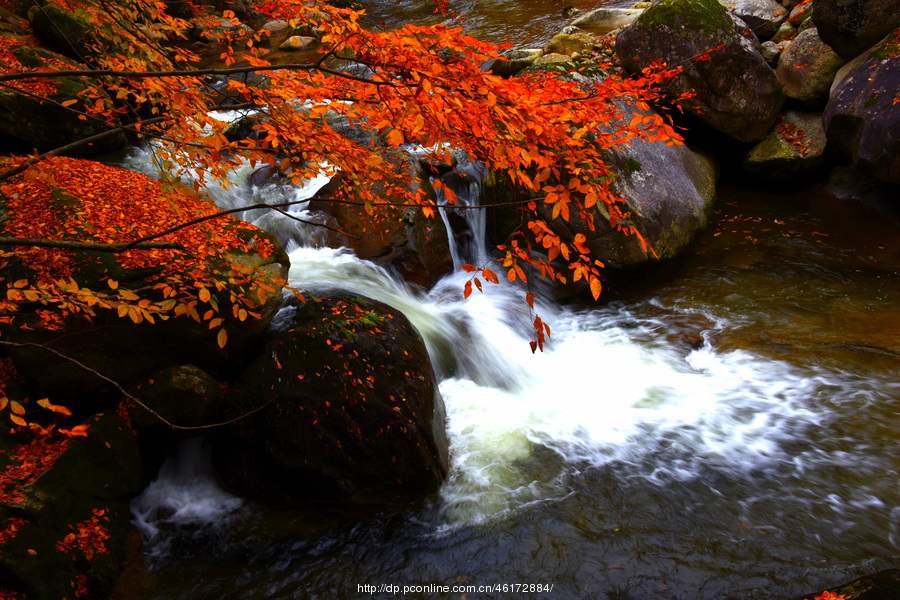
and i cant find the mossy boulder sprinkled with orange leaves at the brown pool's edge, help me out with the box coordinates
[743,111,826,181]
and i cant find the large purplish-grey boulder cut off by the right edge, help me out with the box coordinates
[823,30,900,183]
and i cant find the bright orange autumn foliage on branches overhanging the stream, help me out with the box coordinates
[0,0,679,398]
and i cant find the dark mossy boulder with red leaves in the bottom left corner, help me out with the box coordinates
[0,413,143,600]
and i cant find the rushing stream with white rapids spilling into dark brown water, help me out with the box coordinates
[116,0,900,600]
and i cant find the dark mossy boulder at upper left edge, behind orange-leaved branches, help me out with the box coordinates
[0,34,126,156]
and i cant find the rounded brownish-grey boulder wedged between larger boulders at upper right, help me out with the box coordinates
[775,28,847,108]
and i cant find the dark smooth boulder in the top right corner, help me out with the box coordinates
[813,0,900,60]
